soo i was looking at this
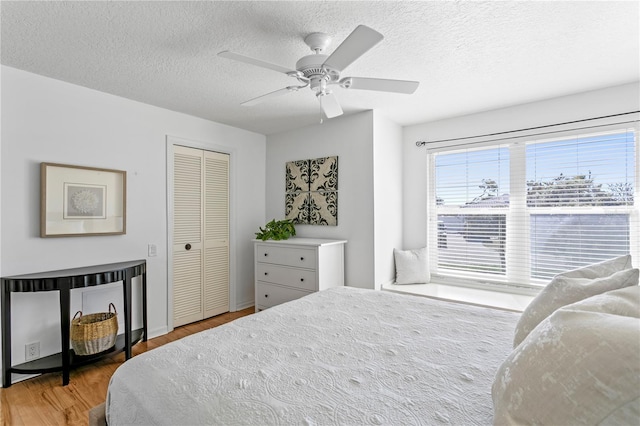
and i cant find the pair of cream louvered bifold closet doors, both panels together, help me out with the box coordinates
[172,145,229,327]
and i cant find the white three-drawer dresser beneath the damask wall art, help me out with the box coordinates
[254,238,346,312]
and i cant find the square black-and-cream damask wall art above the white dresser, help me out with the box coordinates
[285,156,338,226]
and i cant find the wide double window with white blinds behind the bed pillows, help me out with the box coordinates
[427,129,640,286]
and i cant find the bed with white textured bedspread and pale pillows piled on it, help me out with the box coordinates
[106,262,640,426]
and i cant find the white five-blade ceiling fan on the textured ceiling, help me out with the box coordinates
[218,25,420,118]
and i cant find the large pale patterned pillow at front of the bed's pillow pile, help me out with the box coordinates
[492,286,640,425]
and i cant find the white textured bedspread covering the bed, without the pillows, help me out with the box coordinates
[107,287,518,426]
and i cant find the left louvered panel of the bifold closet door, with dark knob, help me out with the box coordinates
[173,146,203,327]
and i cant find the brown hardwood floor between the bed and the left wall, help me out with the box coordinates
[0,307,255,426]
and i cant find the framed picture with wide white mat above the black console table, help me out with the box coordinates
[40,163,127,238]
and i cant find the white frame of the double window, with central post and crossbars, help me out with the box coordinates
[426,127,640,294]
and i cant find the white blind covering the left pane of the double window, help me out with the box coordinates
[435,147,509,275]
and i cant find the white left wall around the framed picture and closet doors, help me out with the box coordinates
[0,67,266,376]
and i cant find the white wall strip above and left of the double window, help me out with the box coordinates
[402,82,640,248]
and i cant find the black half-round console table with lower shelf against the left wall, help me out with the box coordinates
[1,260,147,388]
